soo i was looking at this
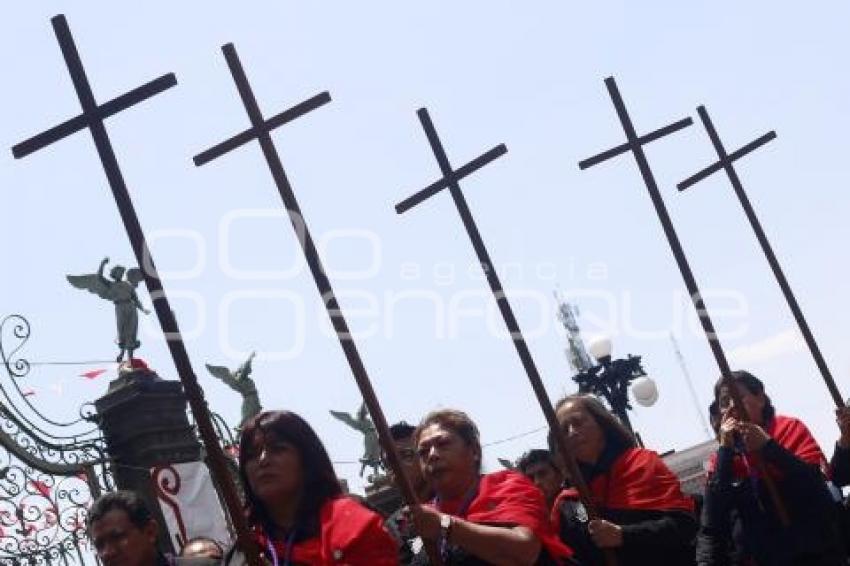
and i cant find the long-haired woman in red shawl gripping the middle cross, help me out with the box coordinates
[550,395,697,566]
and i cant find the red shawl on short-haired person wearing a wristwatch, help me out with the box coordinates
[437,470,573,560]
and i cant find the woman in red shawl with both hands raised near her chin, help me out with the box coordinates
[697,371,846,566]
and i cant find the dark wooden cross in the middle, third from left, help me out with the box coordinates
[395,108,614,564]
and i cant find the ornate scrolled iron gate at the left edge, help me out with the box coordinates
[0,314,113,565]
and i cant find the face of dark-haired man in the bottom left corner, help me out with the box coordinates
[89,509,157,566]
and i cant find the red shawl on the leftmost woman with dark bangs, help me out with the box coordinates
[258,497,398,566]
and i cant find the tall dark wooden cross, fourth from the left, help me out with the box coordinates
[578,77,789,525]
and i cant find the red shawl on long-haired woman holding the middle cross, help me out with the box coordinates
[552,448,694,530]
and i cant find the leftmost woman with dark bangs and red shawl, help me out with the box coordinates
[224,411,398,566]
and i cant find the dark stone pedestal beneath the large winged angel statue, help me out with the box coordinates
[95,369,201,552]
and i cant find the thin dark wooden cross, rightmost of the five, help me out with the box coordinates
[678,106,844,407]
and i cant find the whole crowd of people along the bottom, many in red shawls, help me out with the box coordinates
[88,371,850,566]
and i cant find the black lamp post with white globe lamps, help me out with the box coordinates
[573,338,658,440]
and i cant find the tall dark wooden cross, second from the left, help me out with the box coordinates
[194,43,439,564]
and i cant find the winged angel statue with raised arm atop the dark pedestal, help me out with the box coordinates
[66,257,150,362]
